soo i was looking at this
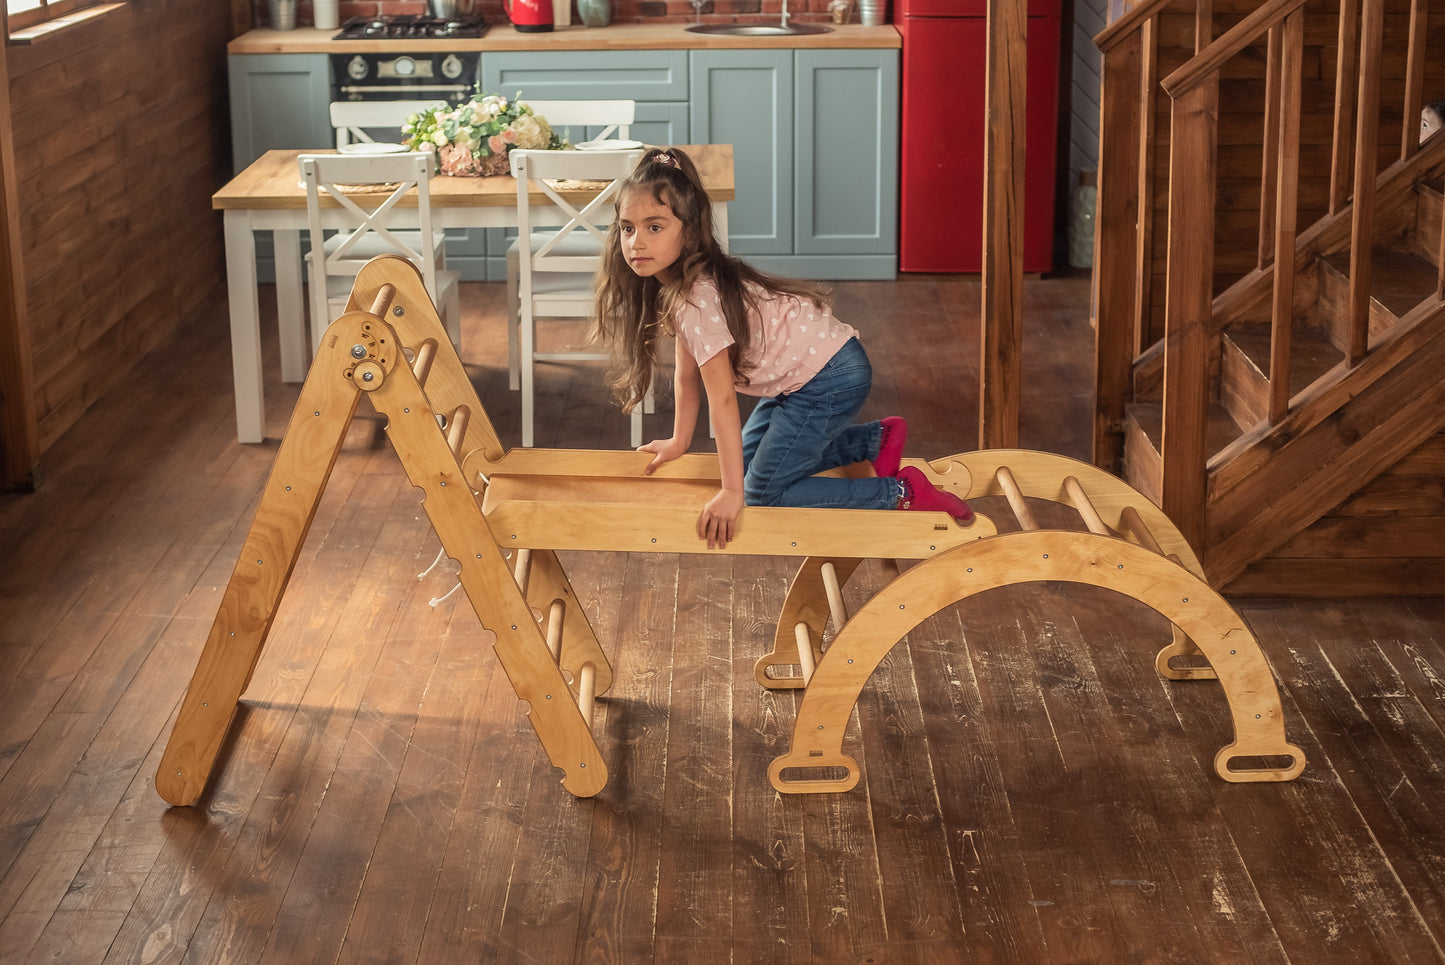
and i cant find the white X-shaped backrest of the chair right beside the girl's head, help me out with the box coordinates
[510,149,643,286]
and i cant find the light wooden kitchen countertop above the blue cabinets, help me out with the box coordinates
[225,23,902,53]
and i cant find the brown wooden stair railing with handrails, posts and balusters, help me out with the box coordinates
[1094,0,1445,545]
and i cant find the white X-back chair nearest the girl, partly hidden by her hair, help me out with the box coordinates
[512,150,642,446]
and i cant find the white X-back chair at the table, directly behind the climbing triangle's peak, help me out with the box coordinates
[299,152,461,355]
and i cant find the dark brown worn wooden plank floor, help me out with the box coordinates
[0,277,1445,965]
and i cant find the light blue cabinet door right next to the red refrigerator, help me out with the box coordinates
[793,51,899,254]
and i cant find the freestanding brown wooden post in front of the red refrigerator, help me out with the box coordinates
[978,0,1027,449]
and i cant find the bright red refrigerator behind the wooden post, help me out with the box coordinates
[893,0,1061,272]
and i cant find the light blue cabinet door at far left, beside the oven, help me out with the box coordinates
[227,53,337,170]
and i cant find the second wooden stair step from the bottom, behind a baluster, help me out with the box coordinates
[1220,322,1344,426]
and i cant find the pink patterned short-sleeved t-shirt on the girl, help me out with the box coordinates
[672,277,858,397]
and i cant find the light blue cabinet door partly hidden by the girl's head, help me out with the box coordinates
[688,51,793,256]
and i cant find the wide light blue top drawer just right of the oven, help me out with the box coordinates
[481,51,688,101]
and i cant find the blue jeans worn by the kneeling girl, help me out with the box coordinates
[743,338,902,510]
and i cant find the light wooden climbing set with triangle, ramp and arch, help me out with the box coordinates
[156,256,1305,805]
